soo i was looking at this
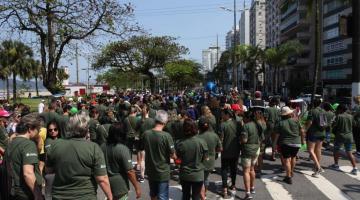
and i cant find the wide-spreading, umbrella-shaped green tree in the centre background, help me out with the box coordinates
[93,35,188,91]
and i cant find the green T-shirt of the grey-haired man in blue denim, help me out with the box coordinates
[142,130,175,181]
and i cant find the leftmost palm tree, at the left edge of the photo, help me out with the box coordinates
[1,40,33,103]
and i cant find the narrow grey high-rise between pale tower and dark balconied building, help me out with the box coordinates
[266,0,281,48]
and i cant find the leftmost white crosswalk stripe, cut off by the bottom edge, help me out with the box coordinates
[261,175,293,200]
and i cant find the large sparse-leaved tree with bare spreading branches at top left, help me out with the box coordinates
[0,0,138,93]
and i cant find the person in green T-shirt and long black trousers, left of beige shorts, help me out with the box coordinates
[220,109,240,198]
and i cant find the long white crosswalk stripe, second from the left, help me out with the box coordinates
[300,170,351,200]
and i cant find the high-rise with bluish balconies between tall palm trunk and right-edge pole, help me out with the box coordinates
[321,0,352,97]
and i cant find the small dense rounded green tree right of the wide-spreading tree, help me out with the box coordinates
[165,60,203,89]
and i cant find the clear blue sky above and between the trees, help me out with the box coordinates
[0,0,251,83]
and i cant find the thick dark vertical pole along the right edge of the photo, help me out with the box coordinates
[352,0,360,105]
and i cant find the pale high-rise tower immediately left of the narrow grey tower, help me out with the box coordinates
[250,0,266,49]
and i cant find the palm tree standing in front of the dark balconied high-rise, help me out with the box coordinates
[265,40,303,93]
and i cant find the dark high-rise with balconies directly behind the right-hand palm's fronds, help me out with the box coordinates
[279,0,315,96]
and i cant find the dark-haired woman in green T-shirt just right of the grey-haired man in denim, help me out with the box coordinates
[176,119,208,200]
